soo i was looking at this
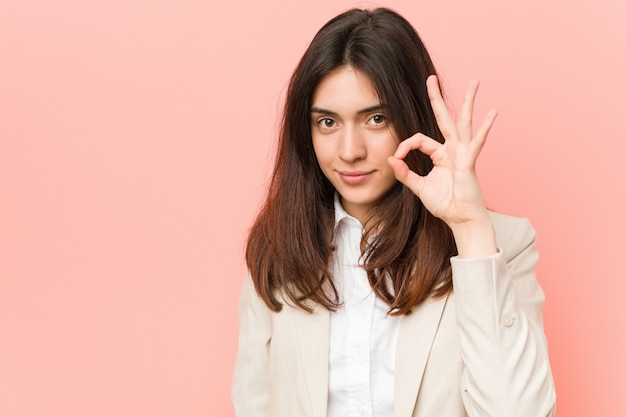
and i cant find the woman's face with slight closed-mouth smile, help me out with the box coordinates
[311,66,398,223]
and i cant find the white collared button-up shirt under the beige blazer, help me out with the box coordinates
[327,197,400,417]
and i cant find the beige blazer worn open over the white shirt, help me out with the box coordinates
[232,214,555,417]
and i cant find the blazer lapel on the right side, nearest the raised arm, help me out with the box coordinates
[394,295,448,417]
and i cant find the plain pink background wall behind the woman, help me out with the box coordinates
[0,0,626,417]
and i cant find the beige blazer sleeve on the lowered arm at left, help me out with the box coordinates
[231,274,272,417]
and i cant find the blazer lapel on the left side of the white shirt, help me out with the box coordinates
[295,306,330,417]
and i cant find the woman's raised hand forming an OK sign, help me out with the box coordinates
[388,75,497,255]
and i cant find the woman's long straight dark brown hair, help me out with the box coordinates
[246,8,456,315]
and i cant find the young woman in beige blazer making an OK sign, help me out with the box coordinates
[232,9,555,417]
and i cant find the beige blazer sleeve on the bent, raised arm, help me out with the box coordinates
[451,218,556,417]
